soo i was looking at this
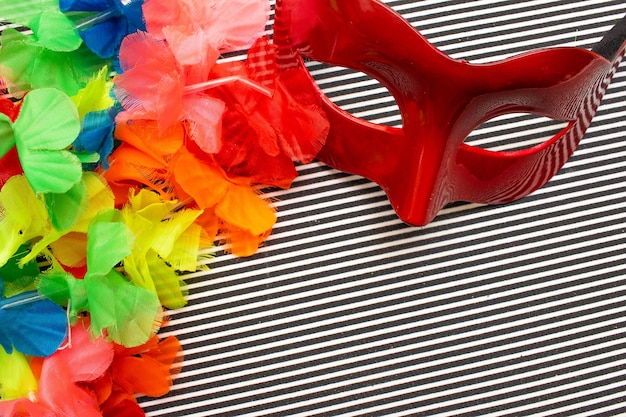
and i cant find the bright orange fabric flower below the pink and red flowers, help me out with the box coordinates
[104,121,276,255]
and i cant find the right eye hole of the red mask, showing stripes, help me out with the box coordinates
[465,113,569,152]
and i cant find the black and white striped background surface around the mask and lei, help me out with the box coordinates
[142,0,626,416]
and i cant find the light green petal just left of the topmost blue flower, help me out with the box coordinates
[29,8,83,52]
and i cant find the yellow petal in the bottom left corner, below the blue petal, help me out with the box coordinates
[0,346,37,401]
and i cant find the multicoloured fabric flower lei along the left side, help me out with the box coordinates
[0,0,328,416]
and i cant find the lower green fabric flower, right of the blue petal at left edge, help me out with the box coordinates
[38,211,161,346]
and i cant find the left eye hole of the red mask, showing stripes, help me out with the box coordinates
[305,61,402,127]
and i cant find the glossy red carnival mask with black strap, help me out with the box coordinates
[274,0,626,225]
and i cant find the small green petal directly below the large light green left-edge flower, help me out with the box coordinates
[44,176,88,230]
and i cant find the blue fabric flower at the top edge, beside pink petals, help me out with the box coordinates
[59,0,146,58]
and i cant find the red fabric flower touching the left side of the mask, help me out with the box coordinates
[214,37,329,177]
